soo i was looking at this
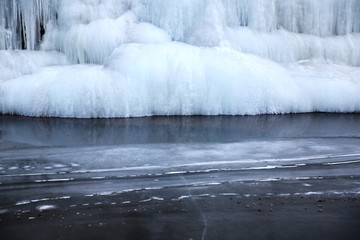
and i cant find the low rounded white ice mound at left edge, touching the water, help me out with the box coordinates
[0,65,121,118]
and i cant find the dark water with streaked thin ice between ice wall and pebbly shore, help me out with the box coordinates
[0,114,360,211]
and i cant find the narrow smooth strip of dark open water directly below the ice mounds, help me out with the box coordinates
[0,114,360,145]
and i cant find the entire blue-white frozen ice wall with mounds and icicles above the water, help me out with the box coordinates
[0,0,360,118]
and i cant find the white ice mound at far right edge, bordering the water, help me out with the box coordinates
[287,62,360,112]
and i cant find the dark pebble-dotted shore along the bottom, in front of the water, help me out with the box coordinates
[0,180,360,240]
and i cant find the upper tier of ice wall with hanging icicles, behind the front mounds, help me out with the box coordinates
[0,0,360,65]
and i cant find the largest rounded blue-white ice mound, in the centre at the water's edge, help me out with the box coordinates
[104,43,303,115]
